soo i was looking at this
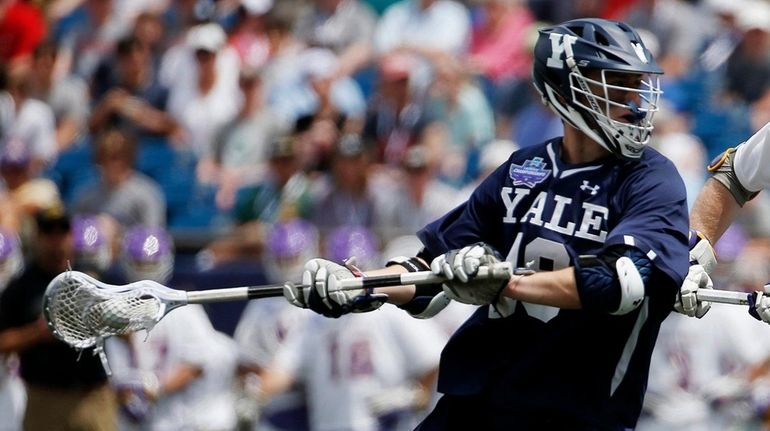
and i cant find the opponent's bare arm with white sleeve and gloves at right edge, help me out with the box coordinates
[677,123,770,323]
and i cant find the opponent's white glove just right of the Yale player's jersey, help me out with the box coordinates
[674,229,717,319]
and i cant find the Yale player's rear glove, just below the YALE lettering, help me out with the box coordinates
[430,242,508,305]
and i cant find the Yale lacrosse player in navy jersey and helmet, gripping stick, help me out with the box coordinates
[284,19,688,430]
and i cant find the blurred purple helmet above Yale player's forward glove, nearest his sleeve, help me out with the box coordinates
[324,226,380,269]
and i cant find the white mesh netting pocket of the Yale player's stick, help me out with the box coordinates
[46,273,161,348]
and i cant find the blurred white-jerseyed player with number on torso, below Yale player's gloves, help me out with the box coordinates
[262,226,446,431]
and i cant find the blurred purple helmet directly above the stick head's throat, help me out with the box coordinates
[120,226,174,283]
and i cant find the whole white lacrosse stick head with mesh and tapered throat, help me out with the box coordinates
[43,271,186,349]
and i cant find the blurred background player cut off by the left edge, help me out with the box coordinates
[0,228,27,431]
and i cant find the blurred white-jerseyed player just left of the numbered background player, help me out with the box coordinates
[235,219,319,431]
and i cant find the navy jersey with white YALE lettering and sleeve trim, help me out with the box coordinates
[418,138,688,429]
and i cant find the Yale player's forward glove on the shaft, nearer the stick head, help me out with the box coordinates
[283,259,388,317]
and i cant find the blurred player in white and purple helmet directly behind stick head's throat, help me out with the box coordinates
[107,226,236,431]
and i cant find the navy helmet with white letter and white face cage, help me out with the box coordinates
[532,18,663,160]
